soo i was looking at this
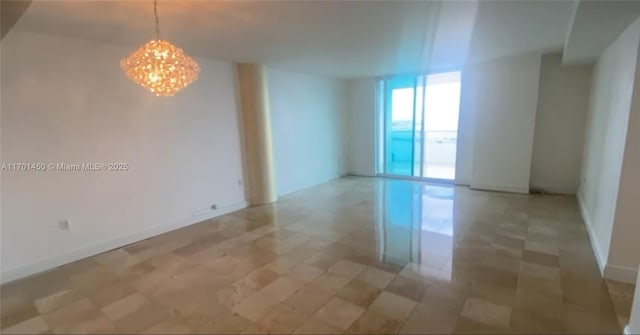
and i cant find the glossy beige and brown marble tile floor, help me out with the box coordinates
[0,177,633,334]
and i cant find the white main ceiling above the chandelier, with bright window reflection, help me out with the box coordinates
[15,0,572,77]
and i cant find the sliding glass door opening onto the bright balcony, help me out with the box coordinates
[378,72,460,180]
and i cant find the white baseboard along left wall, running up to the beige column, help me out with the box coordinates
[0,201,247,283]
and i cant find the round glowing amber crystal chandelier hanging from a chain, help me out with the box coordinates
[120,0,200,96]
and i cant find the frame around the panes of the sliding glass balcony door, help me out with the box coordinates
[375,68,464,185]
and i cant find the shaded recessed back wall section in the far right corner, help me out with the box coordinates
[530,53,593,194]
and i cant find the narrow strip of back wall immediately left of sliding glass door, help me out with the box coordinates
[347,78,377,176]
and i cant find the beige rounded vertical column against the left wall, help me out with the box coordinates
[237,64,278,206]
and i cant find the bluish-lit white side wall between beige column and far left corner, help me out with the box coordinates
[267,69,347,195]
